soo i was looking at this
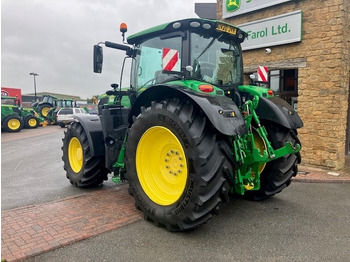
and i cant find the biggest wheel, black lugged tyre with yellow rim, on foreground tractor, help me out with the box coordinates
[126,99,229,231]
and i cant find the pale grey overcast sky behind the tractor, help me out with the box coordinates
[1,0,216,99]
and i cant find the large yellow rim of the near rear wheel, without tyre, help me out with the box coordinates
[136,126,188,206]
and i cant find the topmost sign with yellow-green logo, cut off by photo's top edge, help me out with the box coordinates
[222,0,292,18]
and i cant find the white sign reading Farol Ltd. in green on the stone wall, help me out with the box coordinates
[238,10,302,50]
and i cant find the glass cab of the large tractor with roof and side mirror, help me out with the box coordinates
[94,18,246,101]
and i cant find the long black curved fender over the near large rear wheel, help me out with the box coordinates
[129,85,247,136]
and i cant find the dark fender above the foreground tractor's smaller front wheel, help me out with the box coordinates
[74,114,105,156]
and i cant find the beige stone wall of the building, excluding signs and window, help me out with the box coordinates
[217,0,350,169]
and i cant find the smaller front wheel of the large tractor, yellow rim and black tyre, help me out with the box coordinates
[61,122,109,187]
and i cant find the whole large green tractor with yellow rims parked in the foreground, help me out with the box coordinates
[62,18,303,231]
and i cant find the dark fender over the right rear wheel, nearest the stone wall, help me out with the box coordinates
[256,96,303,129]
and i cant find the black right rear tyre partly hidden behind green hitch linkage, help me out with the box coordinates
[247,122,301,200]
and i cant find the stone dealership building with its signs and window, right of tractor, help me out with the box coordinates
[217,0,350,169]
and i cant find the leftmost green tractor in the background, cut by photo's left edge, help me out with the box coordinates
[1,96,41,132]
